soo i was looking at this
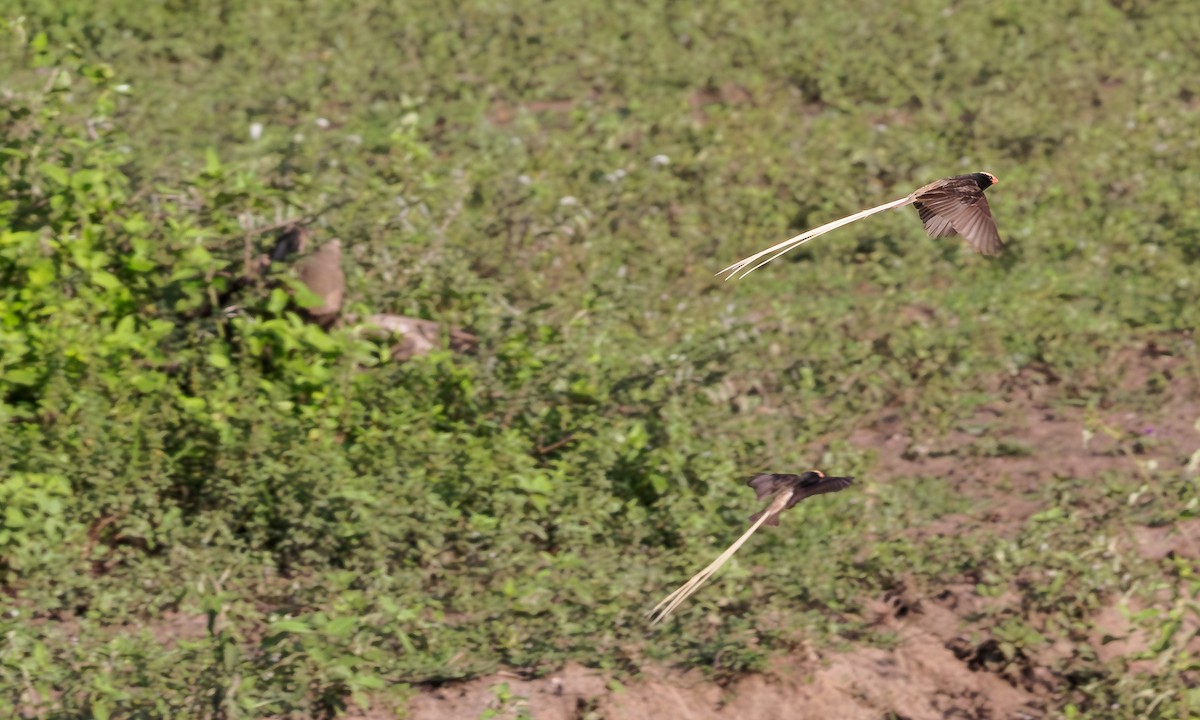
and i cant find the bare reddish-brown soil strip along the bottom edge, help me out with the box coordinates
[409,633,1045,720]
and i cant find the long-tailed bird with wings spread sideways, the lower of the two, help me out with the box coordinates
[646,470,853,625]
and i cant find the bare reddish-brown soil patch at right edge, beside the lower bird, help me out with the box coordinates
[848,342,1200,530]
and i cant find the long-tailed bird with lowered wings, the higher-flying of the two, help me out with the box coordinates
[718,173,1004,280]
